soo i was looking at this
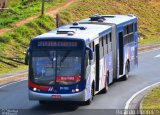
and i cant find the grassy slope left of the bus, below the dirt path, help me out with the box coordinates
[0,16,55,74]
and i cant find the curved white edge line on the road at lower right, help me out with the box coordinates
[125,82,160,110]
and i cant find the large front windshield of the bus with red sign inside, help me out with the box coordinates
[32,50,81,85]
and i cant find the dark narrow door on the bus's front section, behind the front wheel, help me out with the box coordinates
[95,44,100,91]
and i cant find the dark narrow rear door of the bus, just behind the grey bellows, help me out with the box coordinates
[119,32,124,75]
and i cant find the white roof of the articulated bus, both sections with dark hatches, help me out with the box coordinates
[33,15,137,44]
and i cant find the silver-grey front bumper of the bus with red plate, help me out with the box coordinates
[29,90,86,101]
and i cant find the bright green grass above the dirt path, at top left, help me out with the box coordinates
[0,0,68,28]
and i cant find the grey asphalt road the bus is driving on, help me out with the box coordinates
[0,50,160,115]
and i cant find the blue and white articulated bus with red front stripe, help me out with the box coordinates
[25,14,138,104]
